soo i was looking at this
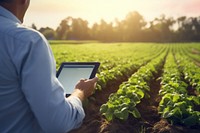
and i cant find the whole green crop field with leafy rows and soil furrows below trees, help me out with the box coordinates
[50,42,200,133]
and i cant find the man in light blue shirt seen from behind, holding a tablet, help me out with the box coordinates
[0,0,97,133]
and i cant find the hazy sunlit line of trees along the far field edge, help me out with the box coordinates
[32,11,200,42]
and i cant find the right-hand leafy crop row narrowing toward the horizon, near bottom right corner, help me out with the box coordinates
[159,53,200,126]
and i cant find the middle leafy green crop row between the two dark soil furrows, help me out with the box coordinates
[100,52,166,121]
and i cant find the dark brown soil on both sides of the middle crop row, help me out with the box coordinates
[70,61,200,133]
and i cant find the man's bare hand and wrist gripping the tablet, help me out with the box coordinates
[71,77,98,101]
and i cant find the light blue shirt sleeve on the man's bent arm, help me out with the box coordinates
[12,30,85,133]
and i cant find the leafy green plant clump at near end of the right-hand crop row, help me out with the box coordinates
[159,93,200,126]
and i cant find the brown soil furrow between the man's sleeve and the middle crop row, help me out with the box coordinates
[70,77,131,133]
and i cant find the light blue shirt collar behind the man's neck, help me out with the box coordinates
[0,6,21,24]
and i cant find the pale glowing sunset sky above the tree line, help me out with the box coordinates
[24,0,200,29]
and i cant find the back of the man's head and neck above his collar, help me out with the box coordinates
[0,0,30,22]
